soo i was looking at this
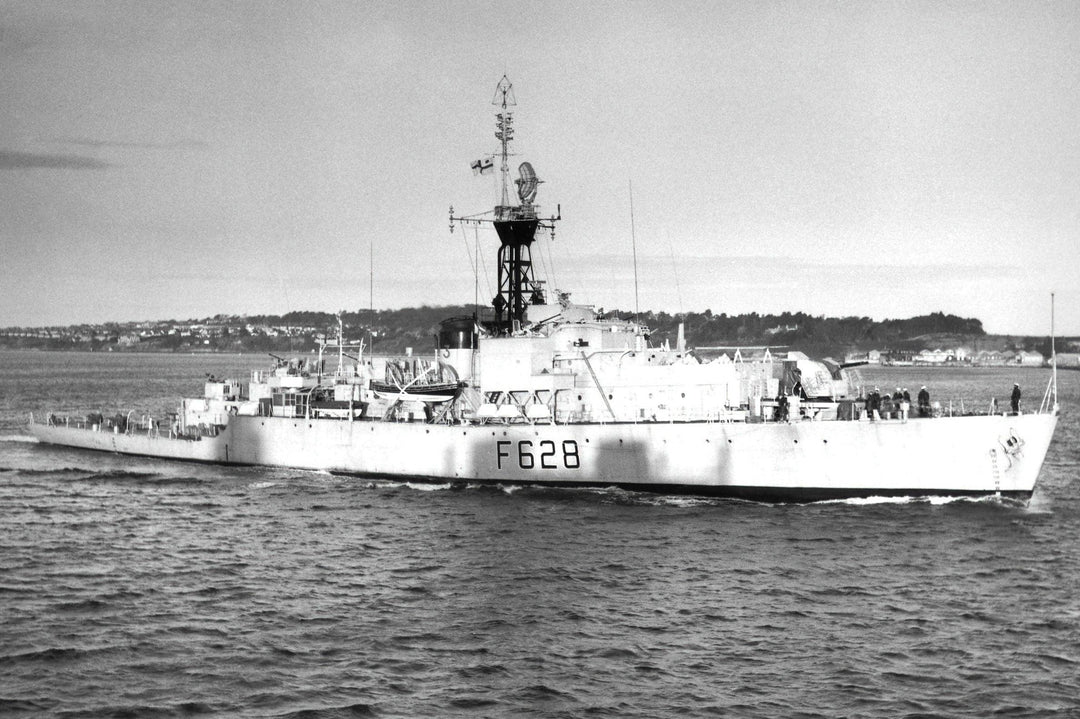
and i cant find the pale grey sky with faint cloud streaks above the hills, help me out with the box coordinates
[0,0,1080,335]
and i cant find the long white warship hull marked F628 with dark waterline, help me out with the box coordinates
[32,415,1057,501]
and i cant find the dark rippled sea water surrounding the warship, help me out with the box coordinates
[0,353,1080,717]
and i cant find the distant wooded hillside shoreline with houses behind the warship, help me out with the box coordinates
[0,304,1080,367]
